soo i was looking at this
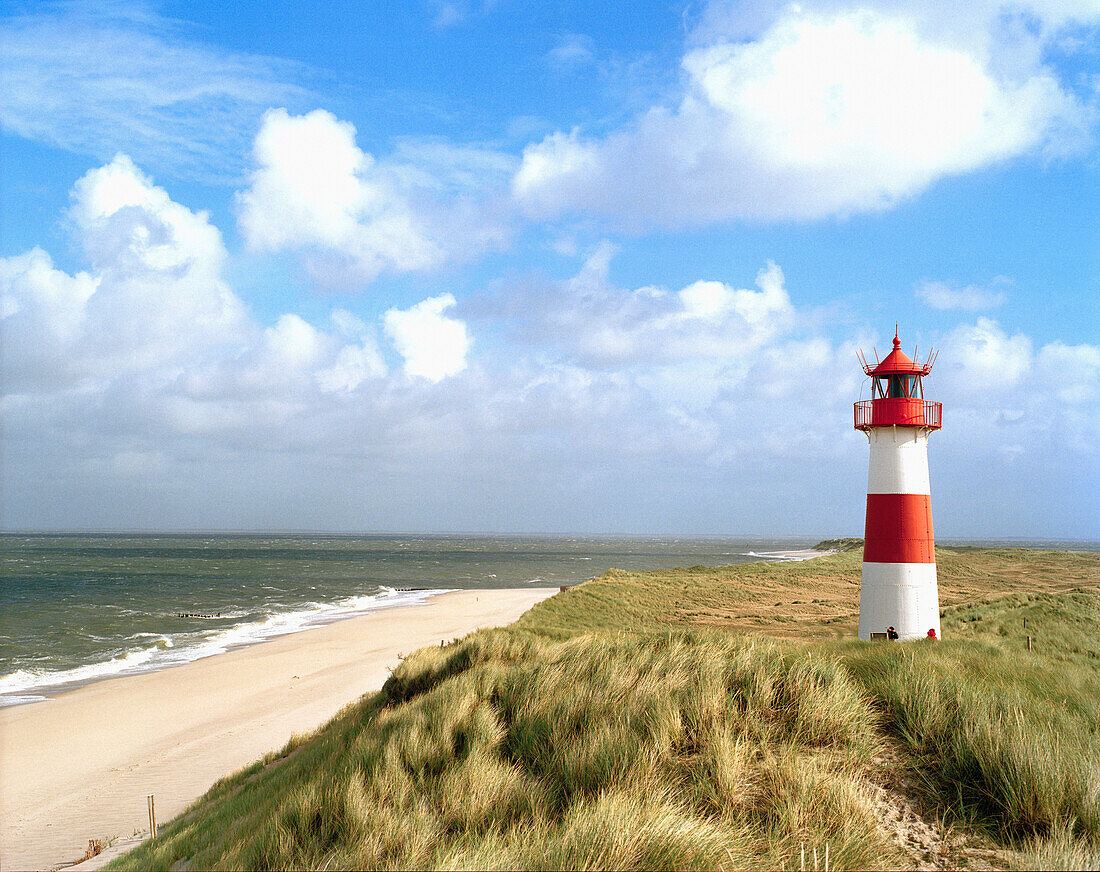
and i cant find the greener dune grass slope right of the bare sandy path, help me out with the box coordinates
[833,589,1100,845]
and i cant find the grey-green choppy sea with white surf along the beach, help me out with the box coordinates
[0,533,812,706]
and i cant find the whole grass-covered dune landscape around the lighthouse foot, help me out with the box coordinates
[112,549,1100,869]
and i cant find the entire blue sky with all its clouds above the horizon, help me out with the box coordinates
[0,0,1100,539]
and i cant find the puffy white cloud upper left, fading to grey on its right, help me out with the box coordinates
[238,109,507,284]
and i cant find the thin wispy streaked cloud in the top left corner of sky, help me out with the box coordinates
[0,4,308,180]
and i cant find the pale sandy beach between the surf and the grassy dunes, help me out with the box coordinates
[0,587,557,870]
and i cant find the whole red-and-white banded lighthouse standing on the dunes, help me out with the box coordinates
[855,330,941,639]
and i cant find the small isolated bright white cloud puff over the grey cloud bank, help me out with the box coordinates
[383,294,473,382]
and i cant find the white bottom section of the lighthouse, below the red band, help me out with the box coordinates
[859,563,939,639]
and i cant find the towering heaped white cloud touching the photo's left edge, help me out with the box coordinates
[2,155,251,387]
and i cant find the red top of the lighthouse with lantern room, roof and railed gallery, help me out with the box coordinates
[855,331,942,432]
